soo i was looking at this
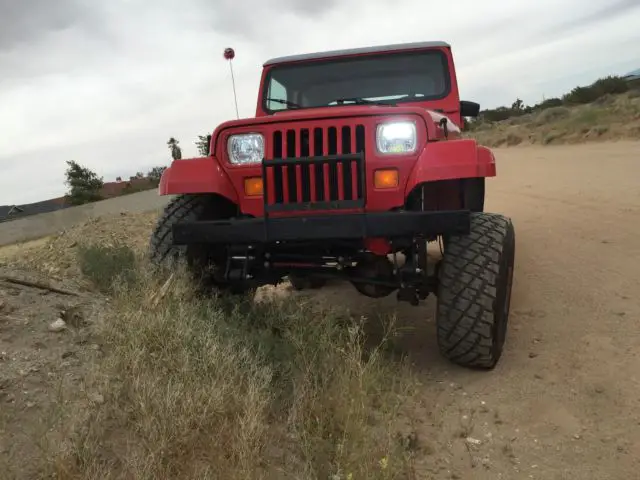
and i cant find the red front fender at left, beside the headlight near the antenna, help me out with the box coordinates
[158,157,238,204]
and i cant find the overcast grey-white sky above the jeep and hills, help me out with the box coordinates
[0,0,640,204]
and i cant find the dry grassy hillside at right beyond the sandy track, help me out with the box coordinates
[468,91,640,147]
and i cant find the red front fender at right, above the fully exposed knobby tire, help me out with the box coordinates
[405,139,496,195]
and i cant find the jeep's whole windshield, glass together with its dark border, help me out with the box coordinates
[263,50,450,113]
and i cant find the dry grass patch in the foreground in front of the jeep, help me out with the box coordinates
[46,246,415,480]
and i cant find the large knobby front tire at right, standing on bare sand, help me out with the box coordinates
[436,213,515,369]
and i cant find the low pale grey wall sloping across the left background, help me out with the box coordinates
[0,189,172,246]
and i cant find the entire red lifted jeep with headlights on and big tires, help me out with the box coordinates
[150,42,515,369]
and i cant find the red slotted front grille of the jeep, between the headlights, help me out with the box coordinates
[263,125,365,211]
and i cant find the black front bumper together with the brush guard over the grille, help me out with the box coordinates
[173,152,470,245]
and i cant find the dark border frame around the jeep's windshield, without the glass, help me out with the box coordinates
[261,48,452,115]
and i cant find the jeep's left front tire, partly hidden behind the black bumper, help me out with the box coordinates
[149,195,250,293]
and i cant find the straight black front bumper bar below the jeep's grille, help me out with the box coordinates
[173,210,470,245]
